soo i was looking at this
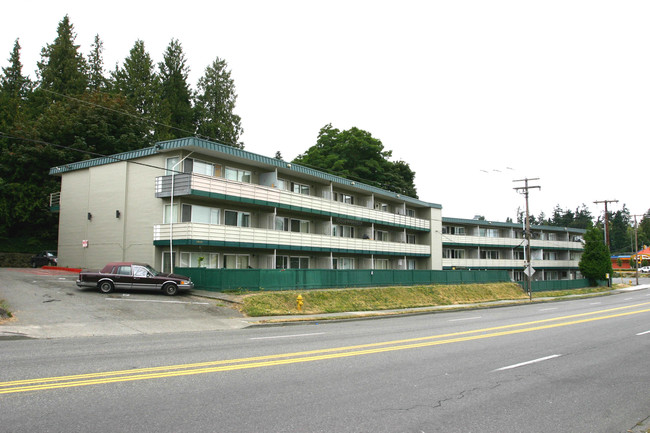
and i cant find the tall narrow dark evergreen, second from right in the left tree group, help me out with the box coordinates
[156,39,195,140]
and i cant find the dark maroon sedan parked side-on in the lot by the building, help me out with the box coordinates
[77,262,194,296]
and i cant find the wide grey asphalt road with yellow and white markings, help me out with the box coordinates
[0,268,650,433]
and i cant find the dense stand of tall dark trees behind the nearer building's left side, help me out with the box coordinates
[0,15,244,251]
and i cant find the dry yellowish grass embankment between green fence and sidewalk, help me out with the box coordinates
[241,283,609,317]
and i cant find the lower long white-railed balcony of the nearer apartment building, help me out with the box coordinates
[153,223,431,257]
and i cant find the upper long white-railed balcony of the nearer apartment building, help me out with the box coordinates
[156,174,431,231]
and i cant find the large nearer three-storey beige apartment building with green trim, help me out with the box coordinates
[50,138,442,270]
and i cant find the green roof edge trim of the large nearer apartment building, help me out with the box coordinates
[49,137,442,209]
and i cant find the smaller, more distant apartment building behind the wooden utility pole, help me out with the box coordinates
[442,218,585,281]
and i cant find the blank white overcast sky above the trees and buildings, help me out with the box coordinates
[5,0,650,221]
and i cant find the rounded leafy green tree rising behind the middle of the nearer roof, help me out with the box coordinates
[293,124,417,198]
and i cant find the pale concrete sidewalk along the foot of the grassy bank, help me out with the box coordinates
[192,284,650,326]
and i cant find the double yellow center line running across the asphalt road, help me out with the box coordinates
[0,302,650,394]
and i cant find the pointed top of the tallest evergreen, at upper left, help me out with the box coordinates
[38,15,88,99]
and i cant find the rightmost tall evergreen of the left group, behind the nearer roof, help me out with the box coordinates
[195,57,244,149]
